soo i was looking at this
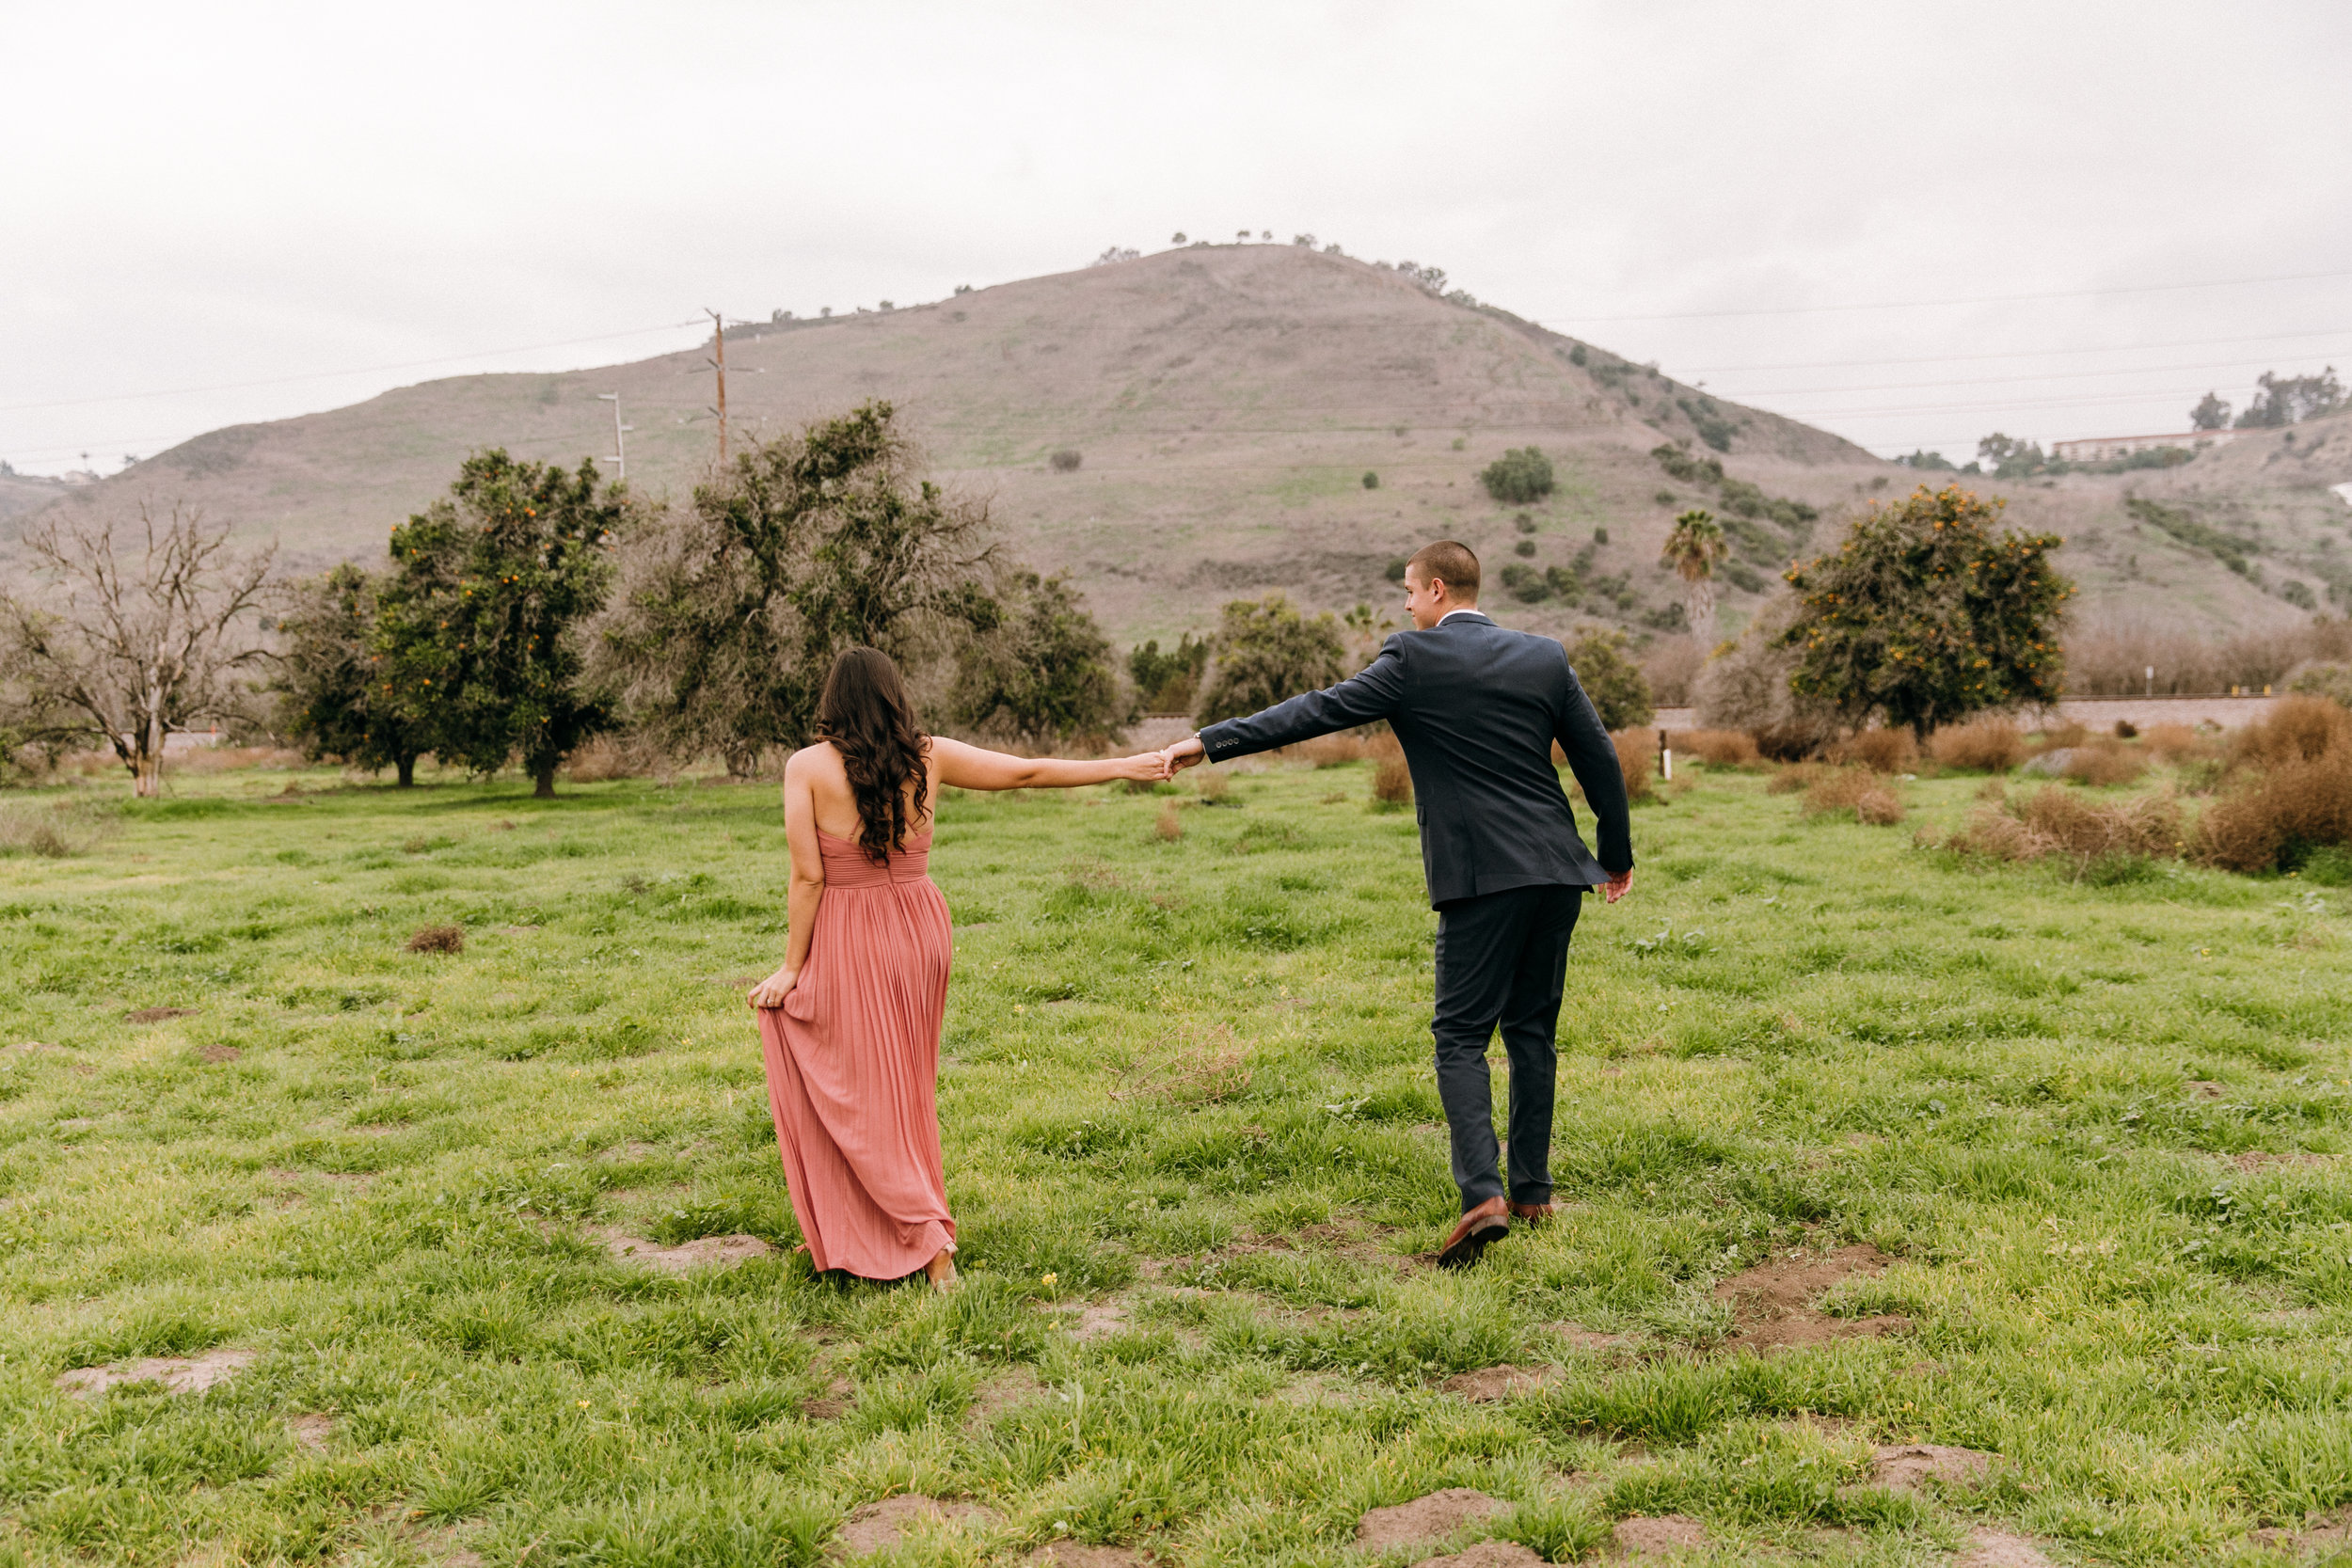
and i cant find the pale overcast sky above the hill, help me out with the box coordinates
[0,0,2352,472]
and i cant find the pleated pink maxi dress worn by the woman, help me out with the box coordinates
[760,828,955,1279]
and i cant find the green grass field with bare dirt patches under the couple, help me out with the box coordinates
[0,764,2352,1568]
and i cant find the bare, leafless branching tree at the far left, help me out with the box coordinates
[0,505,278,795]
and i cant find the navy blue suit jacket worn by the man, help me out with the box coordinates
[1200,611,1632,908]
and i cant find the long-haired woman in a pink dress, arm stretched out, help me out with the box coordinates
[751,649,1167,1289]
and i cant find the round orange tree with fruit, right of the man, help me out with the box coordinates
[1781,484,2074,738]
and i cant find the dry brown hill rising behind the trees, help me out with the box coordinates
[18,245,2352,640]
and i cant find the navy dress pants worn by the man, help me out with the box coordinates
[1430,886,1585,1213]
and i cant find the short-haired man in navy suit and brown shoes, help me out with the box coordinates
[1167,541,1632,1270]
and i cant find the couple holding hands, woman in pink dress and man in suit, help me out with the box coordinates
[751,541,1632,1289]
